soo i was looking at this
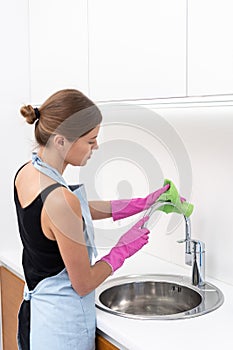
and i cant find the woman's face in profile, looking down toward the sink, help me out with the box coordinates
[65,125,100,166]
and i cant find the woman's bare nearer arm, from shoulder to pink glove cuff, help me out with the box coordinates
[45,187,112,296]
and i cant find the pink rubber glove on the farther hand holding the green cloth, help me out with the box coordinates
[111,184,170,221]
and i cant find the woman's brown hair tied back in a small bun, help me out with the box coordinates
[20,89,102,146]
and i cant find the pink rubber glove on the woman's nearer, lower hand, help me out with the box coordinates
[100,216,150,272]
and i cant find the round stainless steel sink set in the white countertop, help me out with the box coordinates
[96,275,224,320]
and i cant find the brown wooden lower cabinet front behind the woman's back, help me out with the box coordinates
[1,267,24,350]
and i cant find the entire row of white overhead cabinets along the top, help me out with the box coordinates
[29,0,233,105]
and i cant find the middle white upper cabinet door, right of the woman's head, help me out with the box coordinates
[88,0,186,101]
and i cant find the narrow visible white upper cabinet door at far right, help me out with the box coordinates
[188,0,233,96]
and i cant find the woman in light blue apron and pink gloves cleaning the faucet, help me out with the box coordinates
[14,89,169,350]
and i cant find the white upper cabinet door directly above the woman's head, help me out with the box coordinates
[29,0,88,104]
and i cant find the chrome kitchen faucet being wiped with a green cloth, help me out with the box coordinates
[145,202,205,287]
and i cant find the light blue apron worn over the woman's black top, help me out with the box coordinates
[18,154,97,350]
